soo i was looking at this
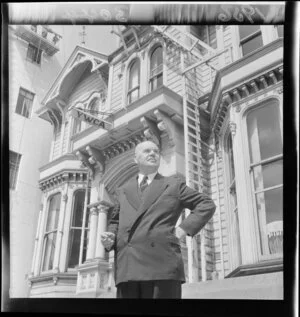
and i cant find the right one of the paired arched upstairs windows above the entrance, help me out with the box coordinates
[150,46,163,91]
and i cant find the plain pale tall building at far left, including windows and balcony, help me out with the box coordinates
[8,25,62,297]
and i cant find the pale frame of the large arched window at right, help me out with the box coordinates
[243,96,283,262]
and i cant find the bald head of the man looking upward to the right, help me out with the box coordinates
[135,141,160,173]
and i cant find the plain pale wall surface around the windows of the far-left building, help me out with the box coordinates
[9,29,61,297]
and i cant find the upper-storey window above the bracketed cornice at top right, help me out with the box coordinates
[238,25,263,56]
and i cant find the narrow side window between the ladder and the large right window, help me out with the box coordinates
[226,132,241,267]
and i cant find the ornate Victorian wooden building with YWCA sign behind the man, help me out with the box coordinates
[29,25,283,298]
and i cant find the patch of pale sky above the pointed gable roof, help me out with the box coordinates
[49,25,118,64]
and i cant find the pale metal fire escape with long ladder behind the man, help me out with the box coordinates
[152,25,227,282]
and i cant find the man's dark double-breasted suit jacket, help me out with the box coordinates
[108,174,216,285]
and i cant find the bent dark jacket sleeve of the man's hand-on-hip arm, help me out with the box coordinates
[178,179,216,236]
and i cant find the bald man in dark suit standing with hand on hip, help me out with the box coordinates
[101,141,216,298]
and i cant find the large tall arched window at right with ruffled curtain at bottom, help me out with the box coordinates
[247,100,283,257]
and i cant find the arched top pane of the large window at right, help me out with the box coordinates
[247,101,282,163]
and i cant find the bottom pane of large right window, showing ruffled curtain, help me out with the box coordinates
[256,188,283,254]
